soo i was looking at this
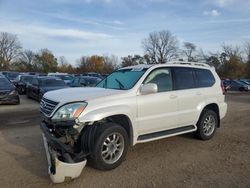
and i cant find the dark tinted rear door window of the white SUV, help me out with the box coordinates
[173,67,195,90]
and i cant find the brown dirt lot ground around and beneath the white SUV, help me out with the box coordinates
[0,93,250,187]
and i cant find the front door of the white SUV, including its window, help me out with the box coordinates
[137,68,178,135]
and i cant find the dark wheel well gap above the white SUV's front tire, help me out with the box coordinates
[106,114,133,145]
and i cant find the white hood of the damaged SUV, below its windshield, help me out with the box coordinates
[44,87,124,103]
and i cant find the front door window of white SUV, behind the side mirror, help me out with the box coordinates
[144,68,173,92]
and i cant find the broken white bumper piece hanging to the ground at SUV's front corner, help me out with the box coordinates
[42,134,87,183]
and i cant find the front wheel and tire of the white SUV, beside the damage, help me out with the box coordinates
[88,123,129,170]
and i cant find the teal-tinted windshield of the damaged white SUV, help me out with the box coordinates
[96,68,147,90]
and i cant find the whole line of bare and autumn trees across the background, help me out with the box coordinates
[0,30,250,79]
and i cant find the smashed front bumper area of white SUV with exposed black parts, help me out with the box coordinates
[40,118,96,183]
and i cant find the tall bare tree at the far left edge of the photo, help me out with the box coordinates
[0,32,21,69]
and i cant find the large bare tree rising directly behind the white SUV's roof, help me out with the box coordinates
[142,30,178,64]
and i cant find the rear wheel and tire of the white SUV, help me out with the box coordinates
[195,109,219,140]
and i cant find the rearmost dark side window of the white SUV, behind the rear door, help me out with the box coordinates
[195,69,215,87]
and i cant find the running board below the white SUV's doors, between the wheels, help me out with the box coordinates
[137,125,196,141]
